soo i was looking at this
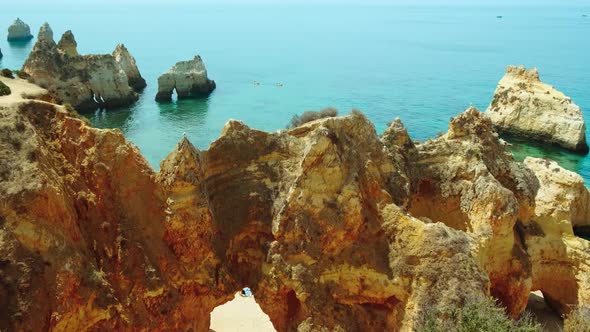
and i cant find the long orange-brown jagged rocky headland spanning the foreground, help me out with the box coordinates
[0,74,590,331]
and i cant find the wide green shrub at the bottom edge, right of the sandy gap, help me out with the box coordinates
[415,297,542,332]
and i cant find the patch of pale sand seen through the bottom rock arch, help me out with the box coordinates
[211,293,276,332]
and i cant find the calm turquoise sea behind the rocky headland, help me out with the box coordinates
[0,1,590,181]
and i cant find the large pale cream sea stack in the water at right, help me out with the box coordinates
[486,66,588,153]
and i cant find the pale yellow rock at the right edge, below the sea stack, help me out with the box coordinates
[520,158,590,314]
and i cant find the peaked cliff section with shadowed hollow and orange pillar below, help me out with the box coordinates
[409,108,538,316]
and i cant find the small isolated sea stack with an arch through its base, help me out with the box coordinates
[156,55,215,101]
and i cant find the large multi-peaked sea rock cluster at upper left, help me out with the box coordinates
[23,24,141,109]
